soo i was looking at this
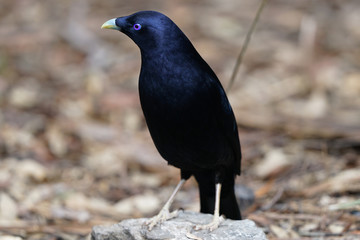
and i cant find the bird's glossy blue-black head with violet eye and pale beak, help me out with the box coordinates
[101,11,183,51]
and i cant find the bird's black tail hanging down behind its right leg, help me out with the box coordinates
[194,171,241,220]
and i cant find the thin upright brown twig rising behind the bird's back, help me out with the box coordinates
[226,0,267,91]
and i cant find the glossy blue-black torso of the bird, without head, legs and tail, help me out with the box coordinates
[139,32,241,174]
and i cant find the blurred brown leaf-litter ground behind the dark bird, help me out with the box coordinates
[0,0,360,240]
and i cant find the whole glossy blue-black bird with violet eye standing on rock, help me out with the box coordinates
[102,11,241,231]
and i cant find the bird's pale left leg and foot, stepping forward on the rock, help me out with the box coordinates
[145,179,186,231]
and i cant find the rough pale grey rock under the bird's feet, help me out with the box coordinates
[91,212,266,240]
